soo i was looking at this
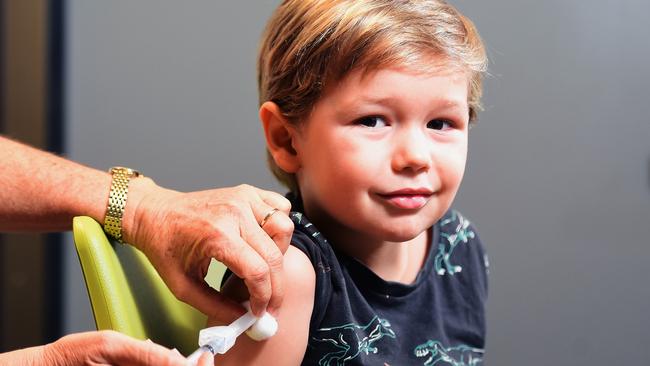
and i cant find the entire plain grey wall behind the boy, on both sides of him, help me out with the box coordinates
[66,0,650,366]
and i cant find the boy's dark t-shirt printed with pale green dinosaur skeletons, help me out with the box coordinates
[291,210,487,366]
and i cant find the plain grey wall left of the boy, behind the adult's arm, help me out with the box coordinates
[65,0,280,332]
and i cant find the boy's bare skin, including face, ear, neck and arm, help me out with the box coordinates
[213,61,469,365]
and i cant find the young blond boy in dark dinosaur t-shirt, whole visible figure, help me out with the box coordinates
[211,0,487,365]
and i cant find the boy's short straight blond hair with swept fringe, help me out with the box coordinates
[257,0,487,192]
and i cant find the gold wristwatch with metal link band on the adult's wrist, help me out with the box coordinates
[104,166,143,243]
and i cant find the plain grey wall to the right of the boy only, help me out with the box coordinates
[450,0,650,365]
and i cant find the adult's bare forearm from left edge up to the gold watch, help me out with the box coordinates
[0,136,111,231]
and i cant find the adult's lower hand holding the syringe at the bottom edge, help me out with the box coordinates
[0,330,214,366]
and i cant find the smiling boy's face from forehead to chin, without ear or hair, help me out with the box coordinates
[294,63,469,242]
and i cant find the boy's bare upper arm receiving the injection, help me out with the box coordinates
[211,246,316,366]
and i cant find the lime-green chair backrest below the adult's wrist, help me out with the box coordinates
[73,216,206,355]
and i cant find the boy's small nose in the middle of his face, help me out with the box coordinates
[392,129,432,172]
